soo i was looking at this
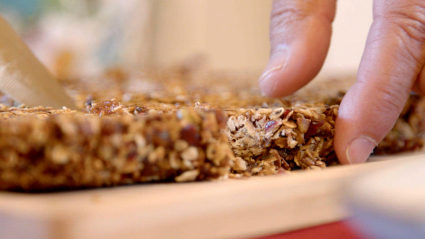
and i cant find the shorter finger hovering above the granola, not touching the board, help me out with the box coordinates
[260,0,336,97]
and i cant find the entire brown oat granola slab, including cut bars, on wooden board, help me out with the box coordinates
[0,69,425,191]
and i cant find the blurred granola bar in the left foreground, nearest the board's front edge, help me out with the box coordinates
[0,107,234,191]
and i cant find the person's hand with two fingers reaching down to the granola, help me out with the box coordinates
[260,0,425,164]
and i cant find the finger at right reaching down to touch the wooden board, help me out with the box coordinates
[334,0,425,163]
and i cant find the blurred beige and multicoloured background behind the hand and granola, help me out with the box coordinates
[0,0,372,77]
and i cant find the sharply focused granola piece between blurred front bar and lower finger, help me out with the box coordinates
[226,104,338,175]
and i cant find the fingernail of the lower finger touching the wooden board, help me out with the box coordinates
[345,136,377,164]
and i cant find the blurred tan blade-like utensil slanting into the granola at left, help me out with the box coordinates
[0,16,76,109]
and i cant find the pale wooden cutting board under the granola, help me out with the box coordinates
[0,154,425,239]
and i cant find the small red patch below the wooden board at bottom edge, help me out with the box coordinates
[252,221,372,239]
